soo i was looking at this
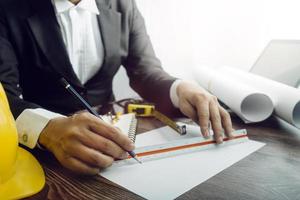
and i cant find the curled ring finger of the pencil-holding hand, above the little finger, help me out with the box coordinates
[69,143,114,168]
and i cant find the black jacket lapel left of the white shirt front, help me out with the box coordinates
[27,0,83,87]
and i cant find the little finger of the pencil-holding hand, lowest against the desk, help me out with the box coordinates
[60,157,100,175]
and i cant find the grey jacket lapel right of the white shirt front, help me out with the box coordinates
[86,0,121,84]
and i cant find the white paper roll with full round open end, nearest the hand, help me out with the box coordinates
[194,67,274,123]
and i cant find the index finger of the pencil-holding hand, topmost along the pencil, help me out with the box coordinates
[89,116,135,151]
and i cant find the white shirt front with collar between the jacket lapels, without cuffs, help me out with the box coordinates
[53,0,104,84]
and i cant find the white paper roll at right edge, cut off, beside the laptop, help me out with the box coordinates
[219,67,300,128]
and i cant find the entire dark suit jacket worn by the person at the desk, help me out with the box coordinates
[0,0,179,117]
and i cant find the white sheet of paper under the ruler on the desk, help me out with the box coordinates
[101,127,264,200]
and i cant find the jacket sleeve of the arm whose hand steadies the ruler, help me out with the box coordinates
[123,0,177,114]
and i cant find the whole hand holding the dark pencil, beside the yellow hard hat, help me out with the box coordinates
[39,113,134,175]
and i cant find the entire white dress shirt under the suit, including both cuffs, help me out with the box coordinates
[16,0,180,148]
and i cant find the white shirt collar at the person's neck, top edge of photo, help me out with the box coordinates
[53,0,100,15]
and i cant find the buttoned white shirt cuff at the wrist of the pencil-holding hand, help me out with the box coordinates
[16,108,63,149]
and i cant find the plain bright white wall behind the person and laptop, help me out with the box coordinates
[114,0,300,98]
